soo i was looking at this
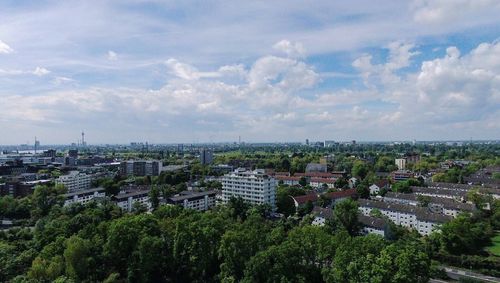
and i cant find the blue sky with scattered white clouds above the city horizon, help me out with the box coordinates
[0,0,500,144]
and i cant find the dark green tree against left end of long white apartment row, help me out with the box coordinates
[333,198,360,236]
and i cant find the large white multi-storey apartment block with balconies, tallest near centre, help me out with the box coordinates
[222,168,277,208]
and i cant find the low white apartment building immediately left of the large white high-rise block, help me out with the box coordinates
[167,191,217,211]
